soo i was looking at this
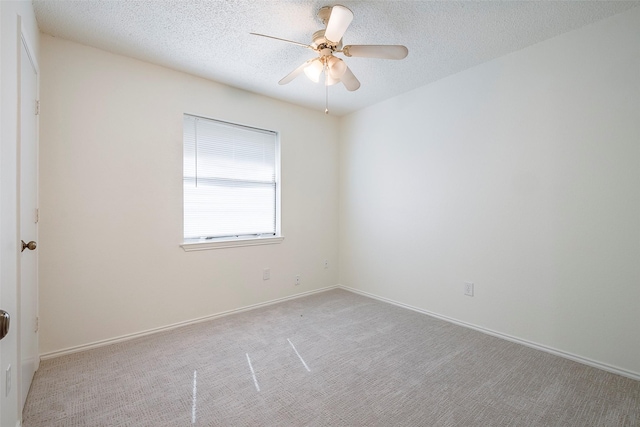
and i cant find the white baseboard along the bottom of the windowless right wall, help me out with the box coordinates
[338,285,640,381]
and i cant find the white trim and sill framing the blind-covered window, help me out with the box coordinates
[180,113,284,252]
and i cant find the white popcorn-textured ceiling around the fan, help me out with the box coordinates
[33,0,640,115]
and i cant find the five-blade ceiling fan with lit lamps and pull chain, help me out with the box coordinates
[251,5,409,114]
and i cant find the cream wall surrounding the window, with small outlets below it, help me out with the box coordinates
[39,35,338,354]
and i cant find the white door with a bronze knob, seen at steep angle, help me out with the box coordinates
[18,36,39,411]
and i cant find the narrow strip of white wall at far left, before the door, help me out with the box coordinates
[0,1,39,426]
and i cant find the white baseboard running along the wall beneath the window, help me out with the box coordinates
[40,285,338,360]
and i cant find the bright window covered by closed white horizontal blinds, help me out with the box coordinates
[183,114,282,250]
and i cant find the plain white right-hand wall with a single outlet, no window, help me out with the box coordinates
[340,8,640,376]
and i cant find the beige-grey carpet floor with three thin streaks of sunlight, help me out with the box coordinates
[23,290,640,427]
